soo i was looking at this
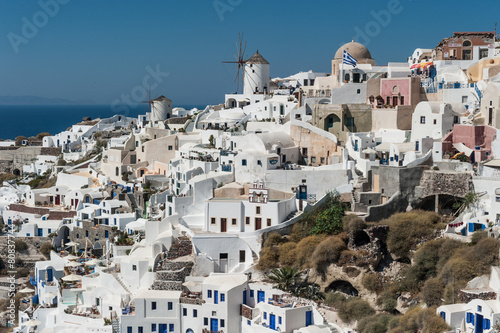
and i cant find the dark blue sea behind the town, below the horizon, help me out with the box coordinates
[0,104,205,140]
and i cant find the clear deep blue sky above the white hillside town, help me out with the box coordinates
[0,0,500,105]
